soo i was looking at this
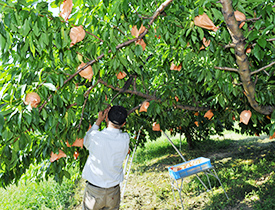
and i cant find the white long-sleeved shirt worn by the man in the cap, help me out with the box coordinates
[82,124,130,188]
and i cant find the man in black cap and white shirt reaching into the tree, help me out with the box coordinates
[82,106,130,210]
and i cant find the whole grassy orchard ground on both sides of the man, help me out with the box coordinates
[0,132,275,210]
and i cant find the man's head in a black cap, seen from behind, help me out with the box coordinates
[108,106,127,128]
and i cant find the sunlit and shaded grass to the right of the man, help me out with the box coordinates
[121,133,275,210]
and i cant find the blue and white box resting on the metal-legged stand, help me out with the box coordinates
[168,157,212,179]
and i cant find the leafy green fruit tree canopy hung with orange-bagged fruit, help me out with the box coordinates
[0,0,275,185]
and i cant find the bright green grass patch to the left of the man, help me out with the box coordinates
[0,166,82,210]
